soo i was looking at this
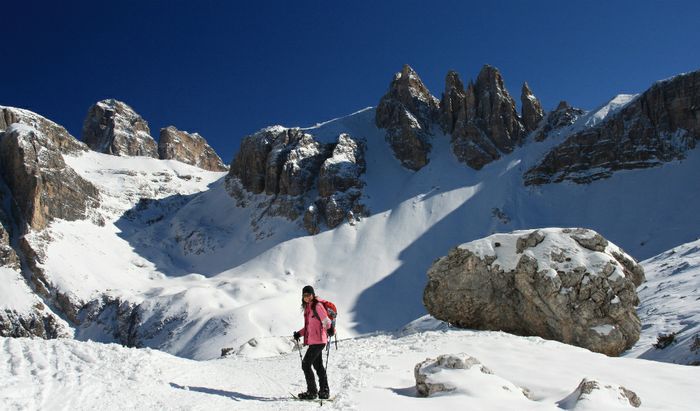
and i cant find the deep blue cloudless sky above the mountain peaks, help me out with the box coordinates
[5,0,700,163]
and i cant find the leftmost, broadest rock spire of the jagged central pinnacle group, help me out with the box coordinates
[376,65,438,170]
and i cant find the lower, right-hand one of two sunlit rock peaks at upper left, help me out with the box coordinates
[158,126,228,171]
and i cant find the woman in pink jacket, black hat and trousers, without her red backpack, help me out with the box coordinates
[294,285,331,400]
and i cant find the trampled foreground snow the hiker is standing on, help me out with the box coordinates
[0,326,700,410]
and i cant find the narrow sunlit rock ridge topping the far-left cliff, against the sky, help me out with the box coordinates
[0,106,88,154]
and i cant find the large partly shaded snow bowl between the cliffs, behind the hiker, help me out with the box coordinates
[21,103,700,359]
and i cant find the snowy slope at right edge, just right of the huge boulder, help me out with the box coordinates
[627,240,700,365]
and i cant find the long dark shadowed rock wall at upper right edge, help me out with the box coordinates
[525,71,700,185]
